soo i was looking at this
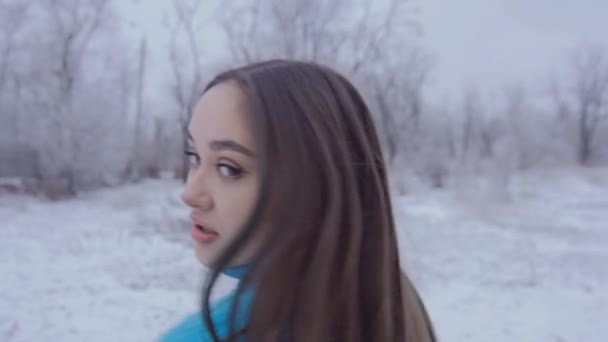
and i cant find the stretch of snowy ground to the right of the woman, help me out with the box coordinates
[397,169,608,342]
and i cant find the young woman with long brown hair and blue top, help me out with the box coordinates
[162,60,435,342]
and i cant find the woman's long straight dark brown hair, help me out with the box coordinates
[198,60,436,342]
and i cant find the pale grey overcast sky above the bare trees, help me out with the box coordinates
[124,0,608,103]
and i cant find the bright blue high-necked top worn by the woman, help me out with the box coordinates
[160,267,253,342]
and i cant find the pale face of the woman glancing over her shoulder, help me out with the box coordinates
[182,81,260,266]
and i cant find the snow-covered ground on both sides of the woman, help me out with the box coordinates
[0,169,608,342]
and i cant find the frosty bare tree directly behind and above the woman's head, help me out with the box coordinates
[220,0,431,163]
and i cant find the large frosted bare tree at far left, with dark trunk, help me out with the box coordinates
[3,0,134,195]
